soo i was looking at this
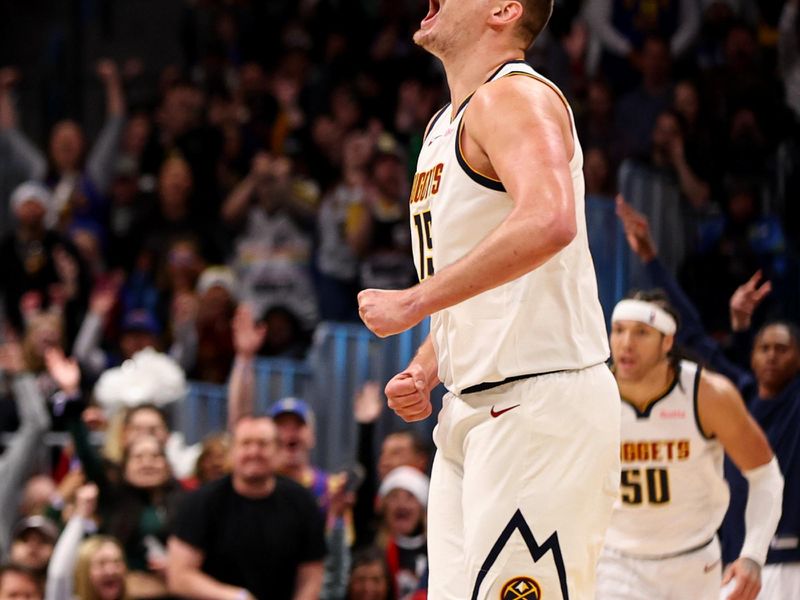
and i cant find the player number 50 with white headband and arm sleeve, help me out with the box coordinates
[597,292,783,600]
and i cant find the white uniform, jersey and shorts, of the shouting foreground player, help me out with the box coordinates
[410,61,619,600]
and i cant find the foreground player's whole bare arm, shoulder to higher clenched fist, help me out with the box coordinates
[359,76,577,336]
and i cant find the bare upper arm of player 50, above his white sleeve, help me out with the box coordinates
[697,372,772,472]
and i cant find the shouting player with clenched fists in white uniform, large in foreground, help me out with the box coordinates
[359,0,619,600]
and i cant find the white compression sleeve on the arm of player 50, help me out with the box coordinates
[739,456,783,565]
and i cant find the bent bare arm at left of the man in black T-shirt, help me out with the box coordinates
[167,536,252,600]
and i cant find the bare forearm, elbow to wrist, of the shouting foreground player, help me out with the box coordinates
[410,210,576,316]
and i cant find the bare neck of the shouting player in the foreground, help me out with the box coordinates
[442,44,525,121]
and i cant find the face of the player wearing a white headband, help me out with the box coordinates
[611,321,674,382]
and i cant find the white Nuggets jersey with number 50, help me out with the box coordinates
[605,361,729,558]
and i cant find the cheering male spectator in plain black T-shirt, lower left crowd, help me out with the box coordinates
[168,417,325,600]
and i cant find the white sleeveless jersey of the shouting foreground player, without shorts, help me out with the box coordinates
[410,61,609,394]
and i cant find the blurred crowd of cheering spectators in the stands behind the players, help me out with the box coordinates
[0,0,800,600]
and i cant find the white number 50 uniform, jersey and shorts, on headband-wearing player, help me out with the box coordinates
[597,361,729,600]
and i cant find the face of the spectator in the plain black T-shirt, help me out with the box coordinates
[231,419,277,485]
